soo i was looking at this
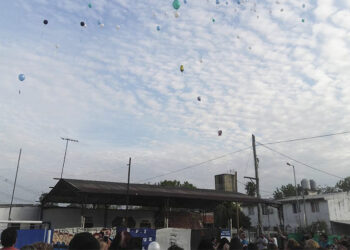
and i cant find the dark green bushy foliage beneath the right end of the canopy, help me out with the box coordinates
[214,202,251,228]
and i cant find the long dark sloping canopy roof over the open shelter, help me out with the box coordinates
[43,179,279,209]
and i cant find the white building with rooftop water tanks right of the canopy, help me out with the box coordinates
[242,192,350,234]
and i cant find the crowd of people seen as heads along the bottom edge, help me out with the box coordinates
[1,228,350,250]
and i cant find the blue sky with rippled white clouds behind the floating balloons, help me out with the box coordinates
[0,0,350,203]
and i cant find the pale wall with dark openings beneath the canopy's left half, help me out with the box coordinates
[43,207,154,229]
